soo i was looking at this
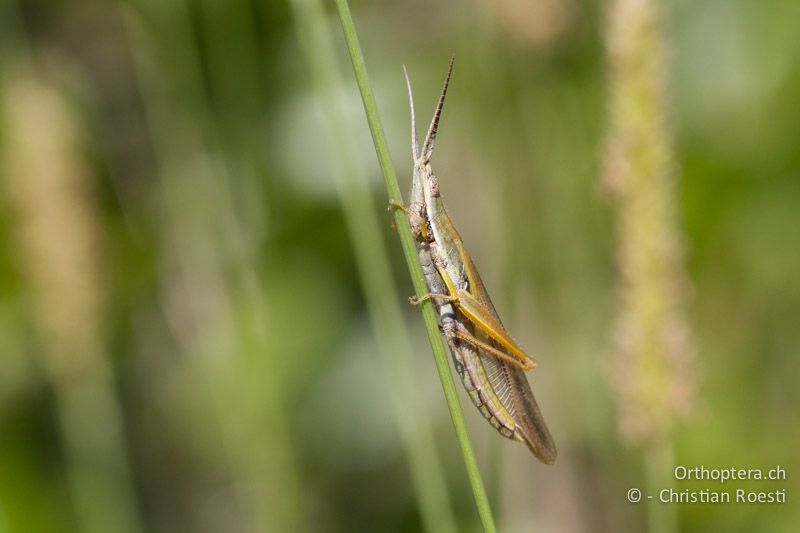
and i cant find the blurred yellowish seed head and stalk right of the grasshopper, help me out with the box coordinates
[602,0,696,533]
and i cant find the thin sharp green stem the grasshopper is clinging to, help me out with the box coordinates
[336,0,496,533]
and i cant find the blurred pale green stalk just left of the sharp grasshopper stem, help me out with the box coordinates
[292,0,456,533]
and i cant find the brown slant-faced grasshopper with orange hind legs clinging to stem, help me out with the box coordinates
[392,60,557,464]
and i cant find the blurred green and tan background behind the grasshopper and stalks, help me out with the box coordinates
[0,0,800,532]
